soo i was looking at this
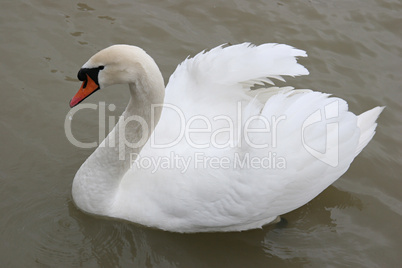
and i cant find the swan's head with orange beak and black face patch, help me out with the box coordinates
[70,45,163,107]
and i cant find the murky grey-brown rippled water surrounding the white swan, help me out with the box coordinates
[0,0,402,267]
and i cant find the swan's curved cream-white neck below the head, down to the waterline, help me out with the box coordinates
[72,64,164,215]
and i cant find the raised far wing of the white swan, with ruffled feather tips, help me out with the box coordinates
[166,43,308,112]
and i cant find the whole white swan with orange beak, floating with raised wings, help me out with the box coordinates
[70,43,383,232]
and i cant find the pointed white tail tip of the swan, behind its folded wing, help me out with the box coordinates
[356,106,385,155]
